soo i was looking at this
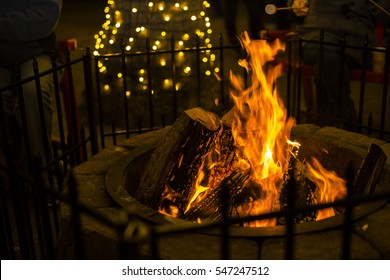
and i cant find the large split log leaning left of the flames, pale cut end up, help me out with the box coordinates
[135,108,220,209]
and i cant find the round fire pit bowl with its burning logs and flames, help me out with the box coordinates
[104,35,386,236]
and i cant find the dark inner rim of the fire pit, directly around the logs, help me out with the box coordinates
[106,128,390,237]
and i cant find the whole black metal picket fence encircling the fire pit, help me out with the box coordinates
[0,33,390,259]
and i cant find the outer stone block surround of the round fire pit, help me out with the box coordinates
[58,124,390,260]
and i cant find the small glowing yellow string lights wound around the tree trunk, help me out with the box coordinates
[94,0,219,96]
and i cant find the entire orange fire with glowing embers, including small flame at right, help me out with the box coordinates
[160,33,346,227]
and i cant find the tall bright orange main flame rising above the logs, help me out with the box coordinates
[231,33,298,226]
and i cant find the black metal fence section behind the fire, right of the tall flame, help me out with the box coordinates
[286,31,390,140]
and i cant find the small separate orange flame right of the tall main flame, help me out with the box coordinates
[307,158,347,221]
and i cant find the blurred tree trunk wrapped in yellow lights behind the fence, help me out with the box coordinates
[94,0,219,128]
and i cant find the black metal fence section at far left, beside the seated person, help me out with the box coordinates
[0,47,98,259]
